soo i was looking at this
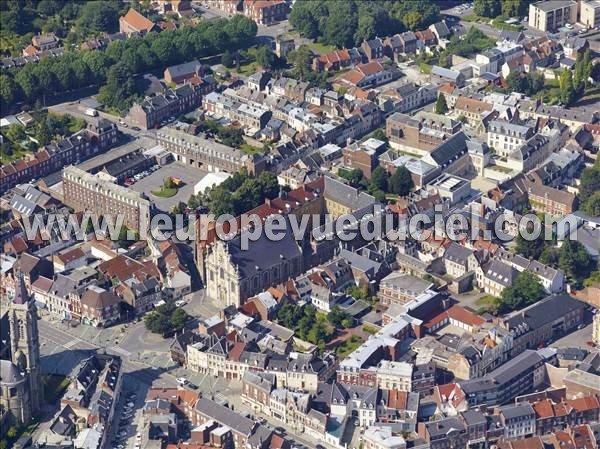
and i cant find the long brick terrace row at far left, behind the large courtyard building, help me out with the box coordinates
[0,119,118,191]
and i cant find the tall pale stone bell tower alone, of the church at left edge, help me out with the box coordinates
[8,273,43,414]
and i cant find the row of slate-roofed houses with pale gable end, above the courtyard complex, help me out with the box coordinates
[127,83,206,129]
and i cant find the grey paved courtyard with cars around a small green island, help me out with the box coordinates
[130,162,206,212]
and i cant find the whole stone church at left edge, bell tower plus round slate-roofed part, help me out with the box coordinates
[0,273,43,427]
